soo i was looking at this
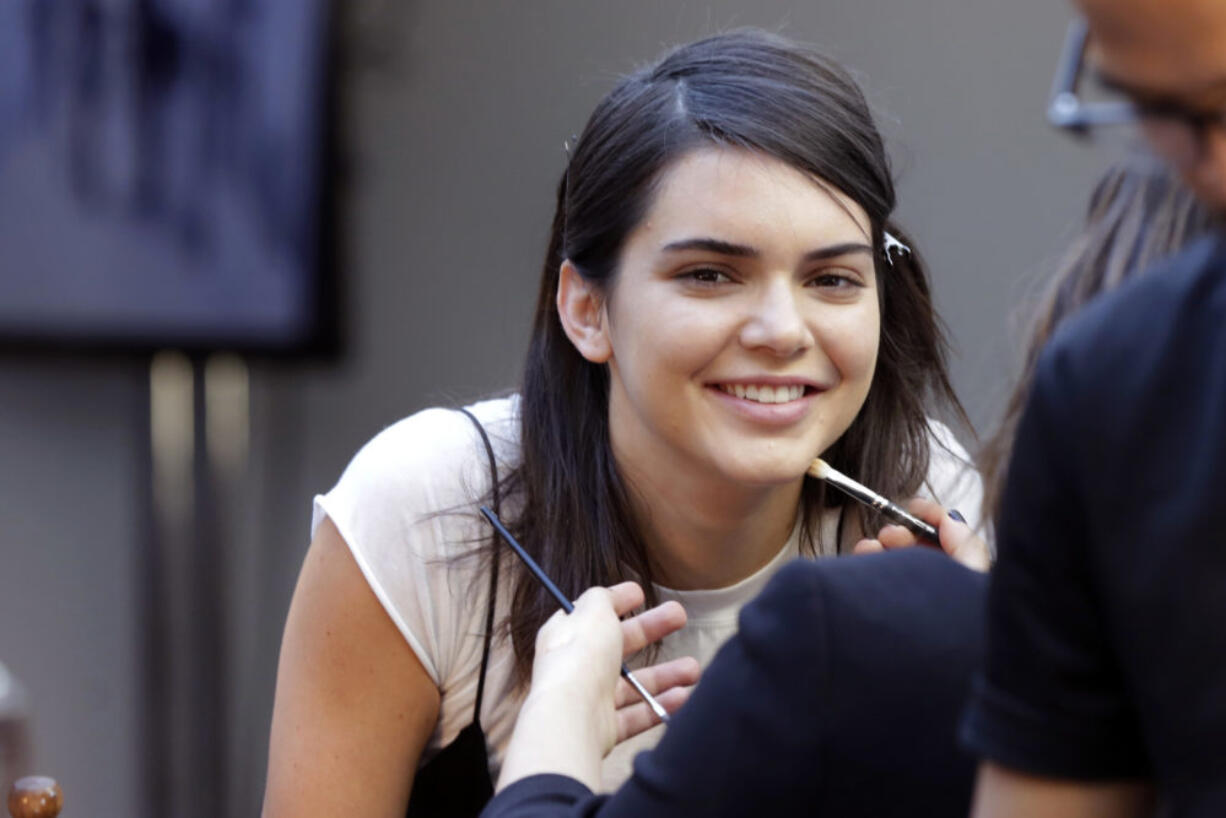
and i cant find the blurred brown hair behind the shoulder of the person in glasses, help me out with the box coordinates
[977,153,1213,519]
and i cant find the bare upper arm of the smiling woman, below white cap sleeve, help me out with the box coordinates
[264,520,439,818]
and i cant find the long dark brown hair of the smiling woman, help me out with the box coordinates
[492,31,965,675]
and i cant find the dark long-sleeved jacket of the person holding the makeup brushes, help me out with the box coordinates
[482,548,986,818]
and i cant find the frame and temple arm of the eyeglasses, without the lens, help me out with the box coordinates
[1047,20,1226,163]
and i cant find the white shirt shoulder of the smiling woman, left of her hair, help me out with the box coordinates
[311,397,519,690]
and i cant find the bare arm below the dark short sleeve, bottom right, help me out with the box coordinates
[971,762,1154,818]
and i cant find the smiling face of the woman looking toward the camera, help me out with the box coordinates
[602,146,880,487]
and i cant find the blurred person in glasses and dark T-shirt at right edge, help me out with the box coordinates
[962,0,1226,818]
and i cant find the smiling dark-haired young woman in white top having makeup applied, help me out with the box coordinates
[265,25,981,816]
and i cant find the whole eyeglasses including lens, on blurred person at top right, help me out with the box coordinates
[1047,20,1226,168]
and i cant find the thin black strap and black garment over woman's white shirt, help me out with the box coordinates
[406,408,501,818]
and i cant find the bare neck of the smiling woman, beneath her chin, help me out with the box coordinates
[618,457,802,590]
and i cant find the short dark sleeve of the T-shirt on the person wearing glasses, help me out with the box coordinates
[962,347,1148,780]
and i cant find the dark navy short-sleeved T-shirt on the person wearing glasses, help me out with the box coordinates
[964,239,1226,816]
